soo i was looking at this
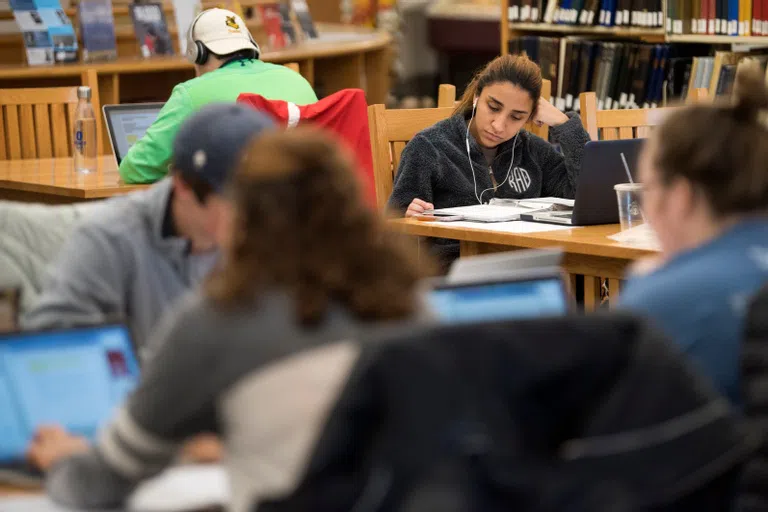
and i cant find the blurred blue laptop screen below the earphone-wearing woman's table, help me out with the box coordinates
[430,278,568,323]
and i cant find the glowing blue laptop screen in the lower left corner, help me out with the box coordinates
[0,325,139,461]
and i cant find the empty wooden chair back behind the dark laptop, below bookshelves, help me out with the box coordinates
[579,89,707,140]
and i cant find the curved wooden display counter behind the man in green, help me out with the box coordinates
[0,24,392,105]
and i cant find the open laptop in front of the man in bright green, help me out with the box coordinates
[103,103,164,165]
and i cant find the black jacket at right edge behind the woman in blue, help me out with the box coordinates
[738,287,768,512]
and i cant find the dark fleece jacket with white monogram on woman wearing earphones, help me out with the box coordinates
[389,114,589,260]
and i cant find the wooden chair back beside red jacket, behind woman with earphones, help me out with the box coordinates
[368,105,453,209]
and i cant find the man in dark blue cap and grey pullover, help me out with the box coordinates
[22,104,273,358]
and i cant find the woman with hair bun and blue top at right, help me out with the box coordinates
[621,61,768,404]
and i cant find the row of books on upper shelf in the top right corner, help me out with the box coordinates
[666,0,768,36]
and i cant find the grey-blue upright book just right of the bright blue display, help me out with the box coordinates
[77,0,117,62]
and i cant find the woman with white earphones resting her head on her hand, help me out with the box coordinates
[389,55,589,262]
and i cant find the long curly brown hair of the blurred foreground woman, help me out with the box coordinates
[207,127,432,325]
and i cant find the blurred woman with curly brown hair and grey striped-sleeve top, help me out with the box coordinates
[30,128,426,511]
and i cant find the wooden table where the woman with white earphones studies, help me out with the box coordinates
[388,219,657,310]
